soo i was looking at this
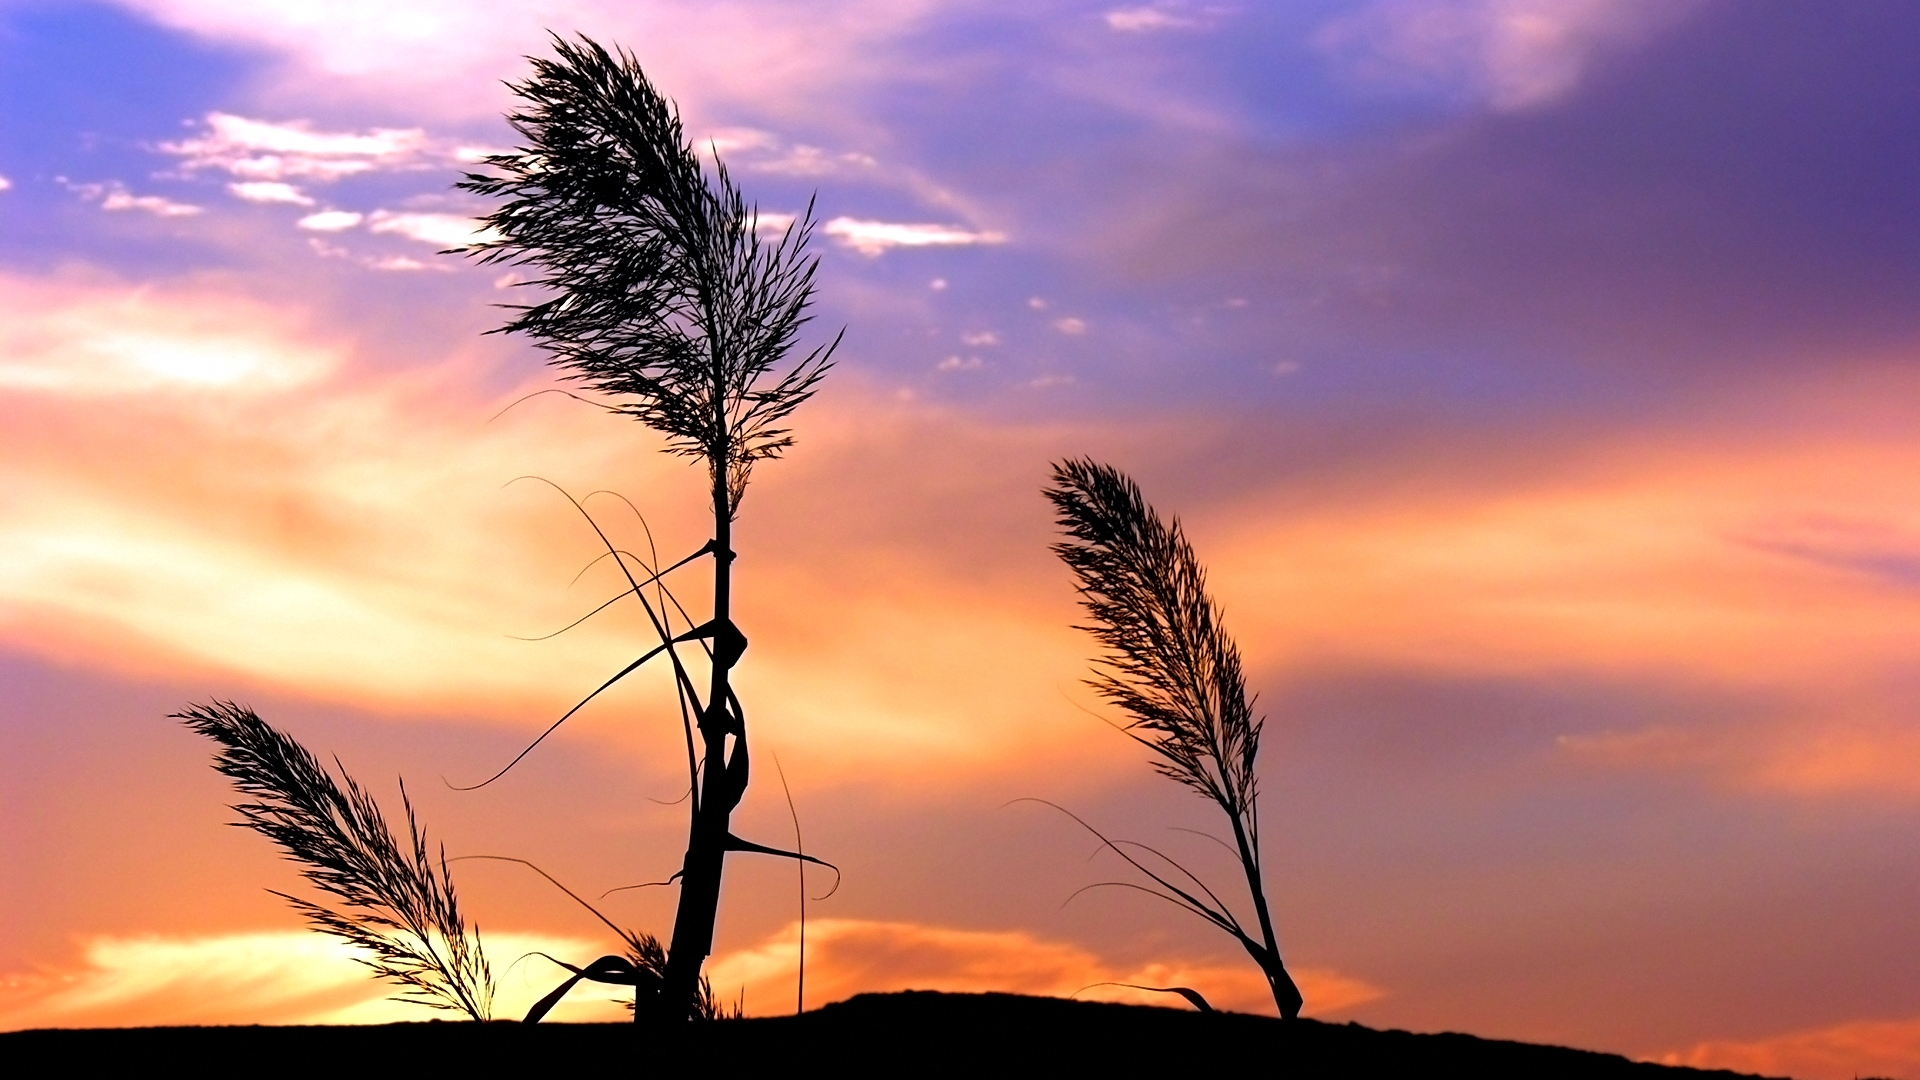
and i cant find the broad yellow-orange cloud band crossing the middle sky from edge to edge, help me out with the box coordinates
[11,270,1920,792]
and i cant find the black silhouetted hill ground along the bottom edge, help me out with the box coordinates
[0,992,1789,1080]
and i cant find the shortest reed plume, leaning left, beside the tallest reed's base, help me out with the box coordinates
[173,701,493,1020]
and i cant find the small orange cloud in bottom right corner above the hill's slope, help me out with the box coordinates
[1659,1020,1920,1080]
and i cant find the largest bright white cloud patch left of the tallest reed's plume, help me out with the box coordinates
[159,111,435,183]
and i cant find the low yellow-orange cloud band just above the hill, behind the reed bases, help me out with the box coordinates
[0,919,1382,1030]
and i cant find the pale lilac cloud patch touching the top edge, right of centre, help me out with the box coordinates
[1315,0,1699,111]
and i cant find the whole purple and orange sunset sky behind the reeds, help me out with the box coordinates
[0,0,1920,1080]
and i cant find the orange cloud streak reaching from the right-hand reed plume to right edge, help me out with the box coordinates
[1208,434,1920,684]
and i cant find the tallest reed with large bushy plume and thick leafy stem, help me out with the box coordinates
[457,37,839,1019]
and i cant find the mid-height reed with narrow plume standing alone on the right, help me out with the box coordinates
[1046,459,1302,1020]
